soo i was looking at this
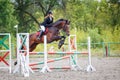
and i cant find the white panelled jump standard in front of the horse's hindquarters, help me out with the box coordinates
[13,33,33,77]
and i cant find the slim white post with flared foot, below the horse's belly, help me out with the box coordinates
[40,35,51,73]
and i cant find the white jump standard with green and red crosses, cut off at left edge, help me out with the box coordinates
[0,33,12,73]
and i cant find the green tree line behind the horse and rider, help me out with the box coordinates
[0,0,120,41]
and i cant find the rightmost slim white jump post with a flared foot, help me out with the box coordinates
[87,37,96,72]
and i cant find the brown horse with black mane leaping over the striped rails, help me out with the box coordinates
[29,19,70,52]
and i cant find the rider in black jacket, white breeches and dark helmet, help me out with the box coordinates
[38,11,53,40]
